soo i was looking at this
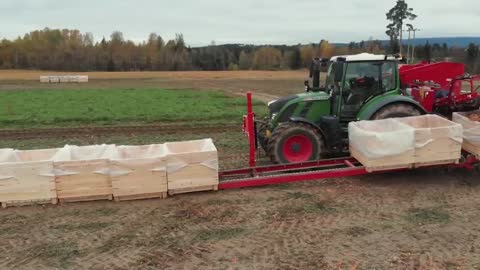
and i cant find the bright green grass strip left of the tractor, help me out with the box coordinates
[0,89,266,128]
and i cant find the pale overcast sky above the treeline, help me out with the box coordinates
[0,0,480,46]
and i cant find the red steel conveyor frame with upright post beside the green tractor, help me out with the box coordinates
[218,92,478,189]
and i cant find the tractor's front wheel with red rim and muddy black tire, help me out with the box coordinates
[268,122,324,164]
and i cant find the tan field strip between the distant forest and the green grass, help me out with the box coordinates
[0,70,308,101]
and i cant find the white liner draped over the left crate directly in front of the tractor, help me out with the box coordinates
[348,119,415,159]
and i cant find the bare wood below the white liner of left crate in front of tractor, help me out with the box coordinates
[350,145,414,172]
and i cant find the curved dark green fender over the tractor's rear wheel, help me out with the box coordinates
[357,95,428,120]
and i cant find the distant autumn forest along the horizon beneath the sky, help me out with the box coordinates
[0,28,480,73]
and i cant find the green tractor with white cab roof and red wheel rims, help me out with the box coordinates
[256,54,426,163]
